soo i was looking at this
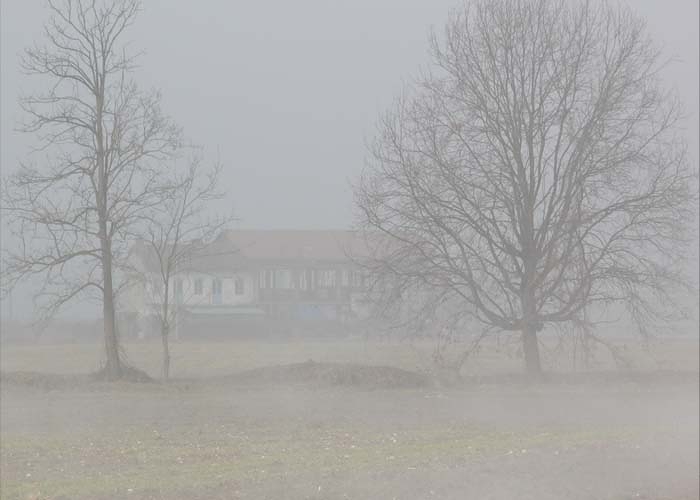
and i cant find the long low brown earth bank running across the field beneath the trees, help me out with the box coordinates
[0,360,700,391]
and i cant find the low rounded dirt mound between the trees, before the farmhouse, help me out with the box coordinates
[222,360,430,389]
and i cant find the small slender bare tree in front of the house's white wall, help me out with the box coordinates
[134,155,233,379]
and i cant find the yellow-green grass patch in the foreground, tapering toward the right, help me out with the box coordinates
[1,426,641,499]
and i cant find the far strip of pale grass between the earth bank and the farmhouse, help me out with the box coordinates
[0,338,699,378]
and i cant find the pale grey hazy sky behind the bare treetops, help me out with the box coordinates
[1,0,699,228]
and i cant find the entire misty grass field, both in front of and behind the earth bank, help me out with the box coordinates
[0,340,699,500]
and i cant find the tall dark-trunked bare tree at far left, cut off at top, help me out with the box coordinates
[3,0,180,378]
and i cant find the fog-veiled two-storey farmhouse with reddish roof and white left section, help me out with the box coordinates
[121,230,368,331]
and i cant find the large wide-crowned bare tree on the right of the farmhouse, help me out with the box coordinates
[356,0,696,374]
